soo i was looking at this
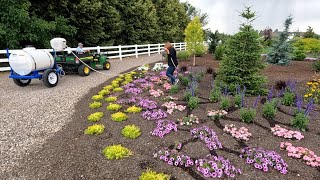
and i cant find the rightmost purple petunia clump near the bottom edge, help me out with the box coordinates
[240,147,288,174]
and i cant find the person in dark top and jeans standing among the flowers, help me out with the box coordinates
[164,42,179,84]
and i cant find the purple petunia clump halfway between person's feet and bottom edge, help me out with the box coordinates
[151,120,178,138]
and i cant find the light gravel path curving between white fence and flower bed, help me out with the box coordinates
[0,55,161,179]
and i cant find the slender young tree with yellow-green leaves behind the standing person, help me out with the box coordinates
[184,16,204,66]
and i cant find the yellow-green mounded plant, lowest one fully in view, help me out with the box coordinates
[102,144,132,160]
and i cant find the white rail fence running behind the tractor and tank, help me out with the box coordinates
[0,42,186,71]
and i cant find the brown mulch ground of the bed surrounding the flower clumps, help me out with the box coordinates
[16,55,320,180]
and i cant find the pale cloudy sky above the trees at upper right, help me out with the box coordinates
[180,0,320,34]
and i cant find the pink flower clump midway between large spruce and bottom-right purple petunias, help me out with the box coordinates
[223,124,252,141]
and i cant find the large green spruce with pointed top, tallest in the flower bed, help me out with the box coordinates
[216,7,266,95]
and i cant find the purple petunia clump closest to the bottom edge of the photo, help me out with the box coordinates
[195,155,242,178]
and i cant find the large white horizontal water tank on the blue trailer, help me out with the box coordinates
[9,47,54,76]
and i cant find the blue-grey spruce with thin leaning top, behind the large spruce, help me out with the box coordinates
[267,16,292,65]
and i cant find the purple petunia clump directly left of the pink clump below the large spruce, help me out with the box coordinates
[190,126,222,150]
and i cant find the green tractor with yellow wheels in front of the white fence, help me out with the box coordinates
[56,52,111,76]
